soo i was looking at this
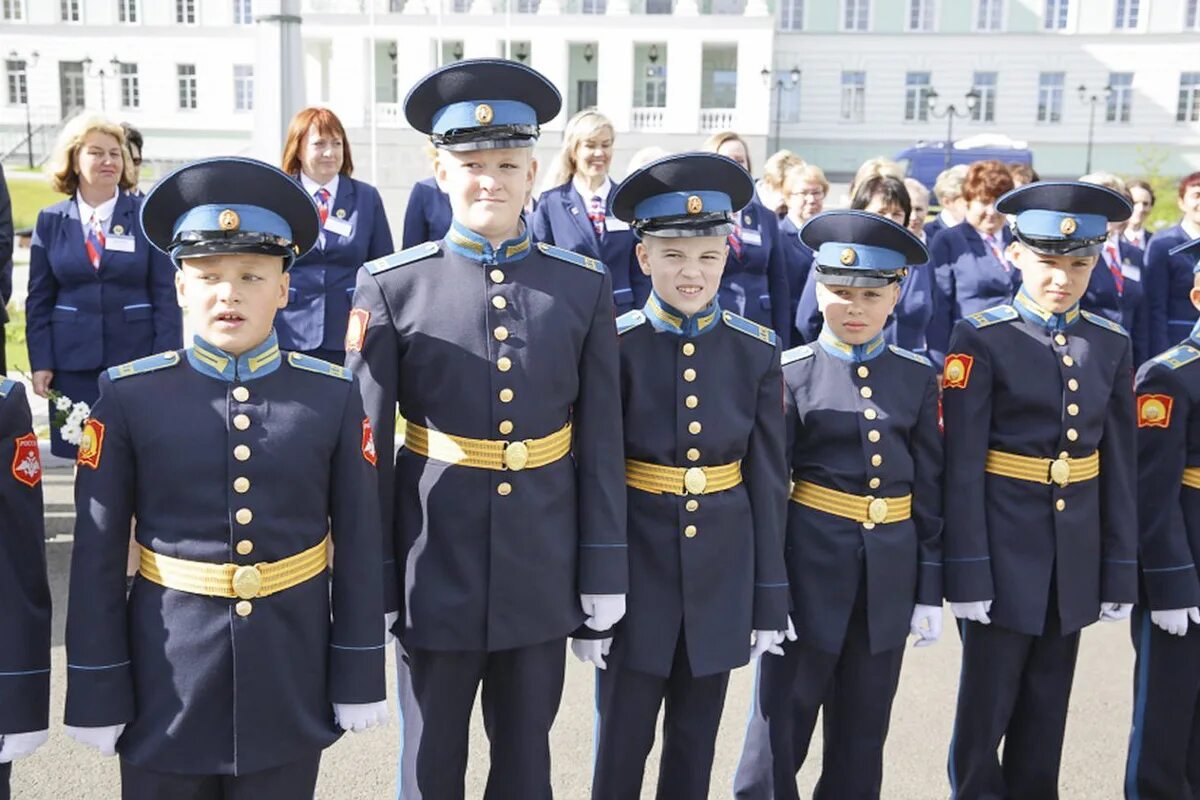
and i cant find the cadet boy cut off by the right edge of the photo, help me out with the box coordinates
[1126,239,1200,800]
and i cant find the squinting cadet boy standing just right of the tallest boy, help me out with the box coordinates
[571,154,787,800]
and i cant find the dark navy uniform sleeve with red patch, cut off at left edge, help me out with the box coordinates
[0,378,50,735]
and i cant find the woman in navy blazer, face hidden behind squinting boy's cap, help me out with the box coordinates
[701,131,792,348]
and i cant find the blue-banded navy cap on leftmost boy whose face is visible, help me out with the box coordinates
[142,157,320,269]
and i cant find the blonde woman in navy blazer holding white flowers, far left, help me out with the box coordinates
[25,116,182,459]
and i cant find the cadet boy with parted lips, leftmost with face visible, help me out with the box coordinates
[66,158,386,800]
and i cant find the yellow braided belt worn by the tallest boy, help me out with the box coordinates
[404,422,571,473]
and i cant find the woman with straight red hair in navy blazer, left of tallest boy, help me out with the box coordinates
[275,108,394,365]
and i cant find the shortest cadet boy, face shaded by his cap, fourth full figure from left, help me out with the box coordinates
[734,211,942,800]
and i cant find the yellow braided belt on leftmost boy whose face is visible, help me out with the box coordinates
[138,536,329,600]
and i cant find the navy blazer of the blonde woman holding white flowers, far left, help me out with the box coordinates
[25,192,182,372]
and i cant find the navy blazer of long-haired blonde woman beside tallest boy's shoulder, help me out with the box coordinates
[529,181,650,314]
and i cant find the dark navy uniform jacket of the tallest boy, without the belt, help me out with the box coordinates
[347,222,628,650]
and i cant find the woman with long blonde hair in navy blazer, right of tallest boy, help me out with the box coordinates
[529,109,650,315]
